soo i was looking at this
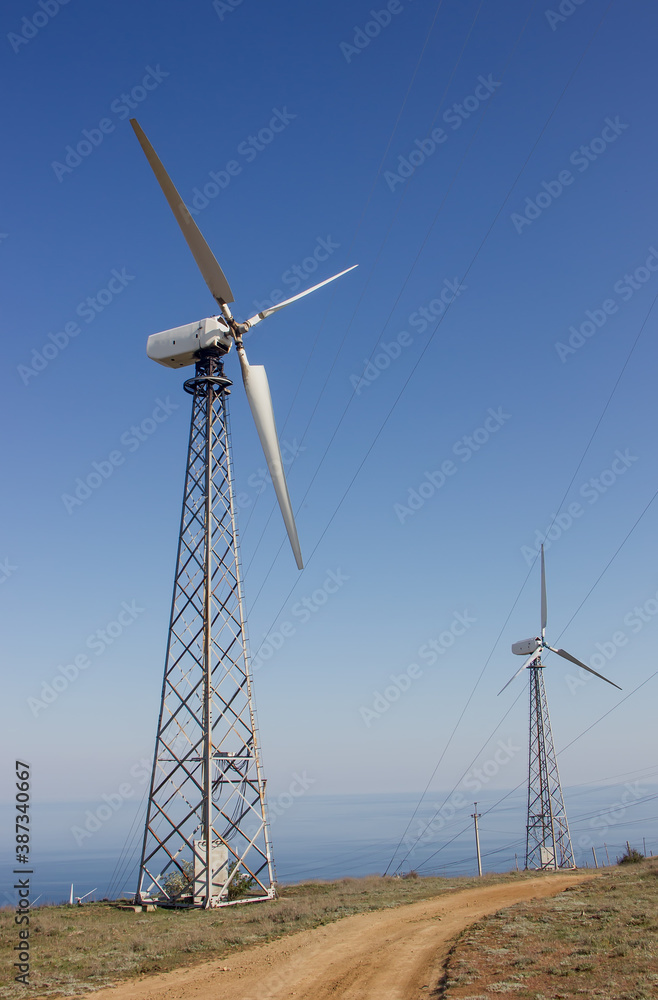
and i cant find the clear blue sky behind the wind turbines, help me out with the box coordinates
[0,0,658,876]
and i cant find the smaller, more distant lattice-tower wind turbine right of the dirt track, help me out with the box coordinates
[498,545,621,870]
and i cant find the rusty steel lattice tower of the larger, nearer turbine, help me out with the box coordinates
[136,348,275,908]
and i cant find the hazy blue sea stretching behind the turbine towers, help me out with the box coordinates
[0,781,658,908]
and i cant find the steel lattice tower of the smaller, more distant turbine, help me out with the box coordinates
[525,657,575,869]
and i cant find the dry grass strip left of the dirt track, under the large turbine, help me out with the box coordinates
[0,873,524,998]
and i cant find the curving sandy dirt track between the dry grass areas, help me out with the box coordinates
[60,872,593,1000]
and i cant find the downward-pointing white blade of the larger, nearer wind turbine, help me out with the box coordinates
[237,345,304,569]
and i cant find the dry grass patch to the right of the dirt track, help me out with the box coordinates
[439,862,658,1000]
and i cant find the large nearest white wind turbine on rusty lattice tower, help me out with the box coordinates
[131,119,356,908]
